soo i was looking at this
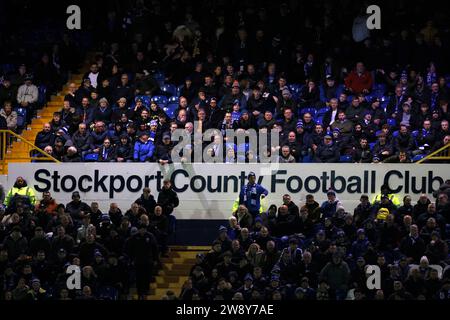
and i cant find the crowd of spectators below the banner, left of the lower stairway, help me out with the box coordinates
[0,177,179,301]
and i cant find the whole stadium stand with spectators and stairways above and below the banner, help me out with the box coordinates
[0,1,450,301]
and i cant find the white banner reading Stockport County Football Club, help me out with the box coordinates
[7,163,450,219]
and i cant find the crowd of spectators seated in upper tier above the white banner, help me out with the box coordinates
[0,1,450,163]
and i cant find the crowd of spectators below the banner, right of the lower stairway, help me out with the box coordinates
[178,181,450,301]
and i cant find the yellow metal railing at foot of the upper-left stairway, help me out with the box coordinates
[0,130,60,174]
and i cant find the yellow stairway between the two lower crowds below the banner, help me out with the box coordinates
[130,246,211,300]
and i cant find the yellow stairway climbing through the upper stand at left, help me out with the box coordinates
[5,70,85,172]
